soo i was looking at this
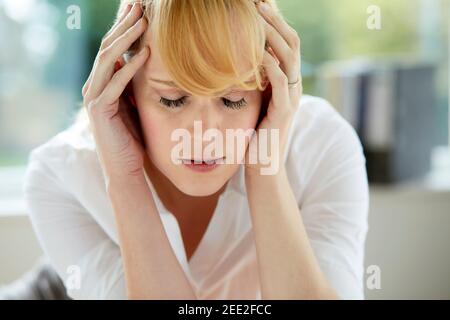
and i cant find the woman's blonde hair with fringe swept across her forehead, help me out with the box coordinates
[74,0,280,124]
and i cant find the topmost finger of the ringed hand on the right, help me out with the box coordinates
[257,1,300,50]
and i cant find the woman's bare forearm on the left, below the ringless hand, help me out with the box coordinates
[108,175,196,299]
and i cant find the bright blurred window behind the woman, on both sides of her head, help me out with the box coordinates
[0,0,450,215]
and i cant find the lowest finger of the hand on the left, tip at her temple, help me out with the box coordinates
[100,46,150,105]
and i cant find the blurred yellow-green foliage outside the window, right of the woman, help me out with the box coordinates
[278,0,450,102]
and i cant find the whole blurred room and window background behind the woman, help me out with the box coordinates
[0,0,450,299]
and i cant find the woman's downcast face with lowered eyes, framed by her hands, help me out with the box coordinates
[132,32,261,196]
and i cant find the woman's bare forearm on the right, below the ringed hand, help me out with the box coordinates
[246,167,337,299]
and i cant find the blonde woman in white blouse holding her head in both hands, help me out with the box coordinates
[25,0,368,299]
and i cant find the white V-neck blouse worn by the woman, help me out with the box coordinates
[24,95,368,299]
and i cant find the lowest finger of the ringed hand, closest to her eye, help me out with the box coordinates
[263,50,290,114]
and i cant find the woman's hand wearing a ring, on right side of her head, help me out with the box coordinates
[245,1,303,175]
